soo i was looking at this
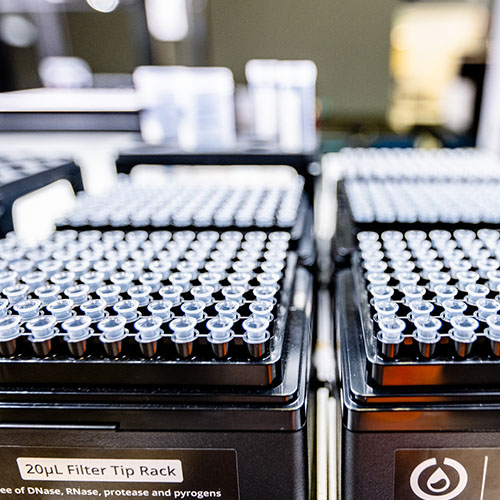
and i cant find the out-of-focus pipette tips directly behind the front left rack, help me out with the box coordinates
[58,175,304,228]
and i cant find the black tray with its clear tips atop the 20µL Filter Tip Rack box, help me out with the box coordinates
[0,231,297,386]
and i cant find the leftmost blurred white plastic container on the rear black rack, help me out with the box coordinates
[134,66,187,144]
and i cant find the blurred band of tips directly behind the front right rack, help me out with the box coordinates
[345,179,500,224]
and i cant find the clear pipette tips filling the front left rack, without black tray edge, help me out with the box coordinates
[0,230,290,359]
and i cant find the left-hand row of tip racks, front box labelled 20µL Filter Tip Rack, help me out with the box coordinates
[0,169,312,500]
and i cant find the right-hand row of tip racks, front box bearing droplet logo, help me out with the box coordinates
[335,150,500,500]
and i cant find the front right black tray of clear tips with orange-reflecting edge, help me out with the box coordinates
[353,229,500,386]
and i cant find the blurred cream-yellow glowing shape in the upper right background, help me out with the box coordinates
[388,2,490,132]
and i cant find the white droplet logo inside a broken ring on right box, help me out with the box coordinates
[410,458,468,500]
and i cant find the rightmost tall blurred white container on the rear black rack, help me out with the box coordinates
[276,60,317,153]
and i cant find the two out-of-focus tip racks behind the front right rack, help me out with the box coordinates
[336,149,500,260]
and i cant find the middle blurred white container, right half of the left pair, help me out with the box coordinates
[178,67,236,151]
